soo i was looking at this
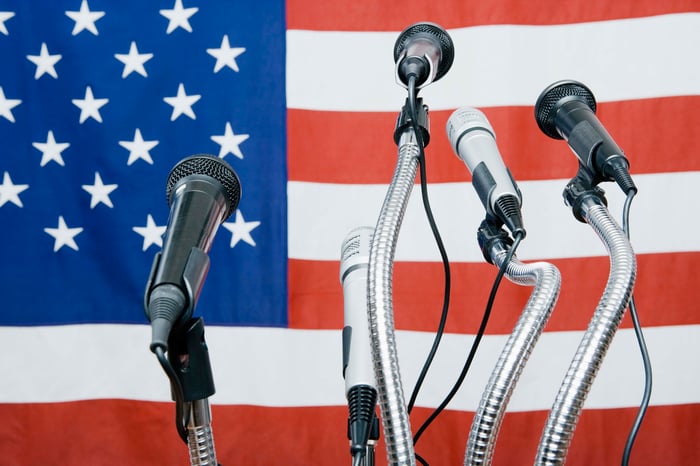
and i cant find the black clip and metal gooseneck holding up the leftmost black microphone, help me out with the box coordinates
[168,317,217,466]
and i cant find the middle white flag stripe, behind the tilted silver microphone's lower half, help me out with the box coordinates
[288,171,700,263]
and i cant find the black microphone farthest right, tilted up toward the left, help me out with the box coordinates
[535,80,637,193]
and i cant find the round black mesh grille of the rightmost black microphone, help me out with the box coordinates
[535,80,596,139]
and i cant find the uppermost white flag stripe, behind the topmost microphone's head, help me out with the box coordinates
[287,13,700,111]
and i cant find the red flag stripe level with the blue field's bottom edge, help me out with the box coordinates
[289,252,700,334]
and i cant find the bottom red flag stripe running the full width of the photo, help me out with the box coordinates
[0,400,700,466]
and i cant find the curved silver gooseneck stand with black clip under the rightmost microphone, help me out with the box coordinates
[535,172,637,465]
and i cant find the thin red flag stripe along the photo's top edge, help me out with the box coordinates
[287,0,698,31]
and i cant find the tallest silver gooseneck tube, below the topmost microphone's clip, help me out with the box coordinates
[367,130,419,466]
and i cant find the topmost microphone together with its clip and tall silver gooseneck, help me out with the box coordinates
[367,23,454,466]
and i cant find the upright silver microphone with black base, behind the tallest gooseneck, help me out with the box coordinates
[340,227,377,456]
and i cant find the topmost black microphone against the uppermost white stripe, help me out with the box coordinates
[394,23,455,89]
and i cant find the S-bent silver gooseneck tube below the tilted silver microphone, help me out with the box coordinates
[464,244,561,466]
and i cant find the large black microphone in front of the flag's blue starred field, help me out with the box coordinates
[144,154,241,351]
